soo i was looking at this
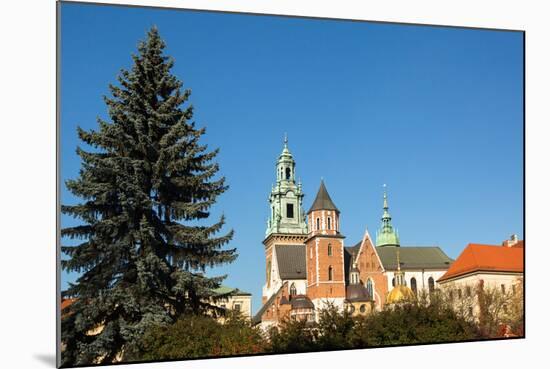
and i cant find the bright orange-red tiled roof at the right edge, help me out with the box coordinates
[438,241,523,282]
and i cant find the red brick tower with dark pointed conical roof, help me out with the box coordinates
[306,181,346,309]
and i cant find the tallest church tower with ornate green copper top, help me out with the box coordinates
[262,135,307,304]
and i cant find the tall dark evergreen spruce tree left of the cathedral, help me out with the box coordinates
[62,27,237,366]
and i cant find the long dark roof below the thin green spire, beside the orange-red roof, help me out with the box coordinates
[376,246,453,270]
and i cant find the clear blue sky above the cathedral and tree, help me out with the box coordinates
[60,3,523,312]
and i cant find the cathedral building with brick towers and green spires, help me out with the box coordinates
[252,138,452,328]
